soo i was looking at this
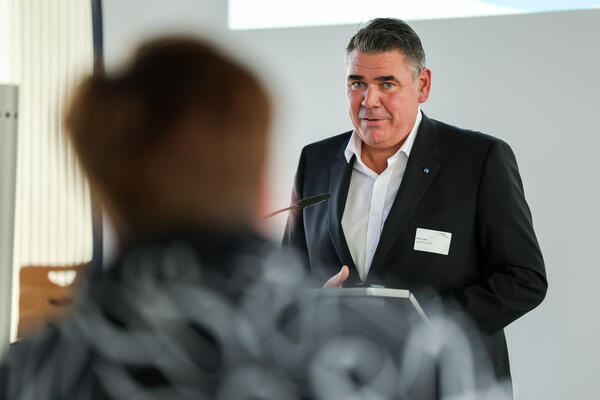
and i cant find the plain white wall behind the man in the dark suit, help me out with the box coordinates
[103,0,600,400]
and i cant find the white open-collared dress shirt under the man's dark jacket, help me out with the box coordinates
[342,109,422,282]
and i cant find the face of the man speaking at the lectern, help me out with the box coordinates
[346,49,431,151]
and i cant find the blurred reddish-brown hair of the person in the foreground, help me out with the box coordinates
[65,38,271,231]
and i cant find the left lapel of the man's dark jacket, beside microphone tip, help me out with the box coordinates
[328,150,360,285]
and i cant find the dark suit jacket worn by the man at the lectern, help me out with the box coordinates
[284,111,547,377]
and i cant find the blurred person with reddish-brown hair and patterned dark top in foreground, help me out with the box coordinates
[0,38,510,400]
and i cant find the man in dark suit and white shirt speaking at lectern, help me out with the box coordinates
[284,19,547,390]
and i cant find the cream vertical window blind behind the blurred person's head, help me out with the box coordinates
[0,0,93,338]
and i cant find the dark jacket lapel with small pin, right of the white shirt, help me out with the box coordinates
[369,114,440,277]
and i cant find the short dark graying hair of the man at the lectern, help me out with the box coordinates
[346,18,425,79]
